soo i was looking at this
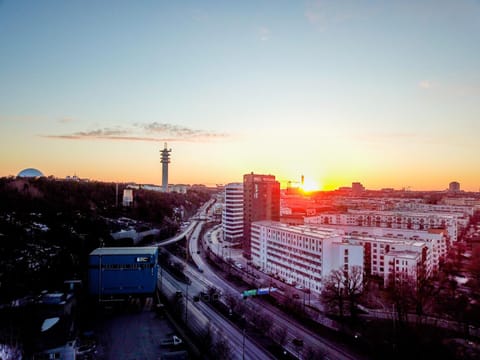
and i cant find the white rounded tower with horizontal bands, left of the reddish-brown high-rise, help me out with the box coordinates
[222,183,243,243]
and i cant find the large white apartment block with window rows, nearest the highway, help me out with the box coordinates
[251,221,363,293]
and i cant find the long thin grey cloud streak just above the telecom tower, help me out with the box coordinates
[41,122,229,142]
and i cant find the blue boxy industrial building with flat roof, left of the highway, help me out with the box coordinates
[88,247,158,300]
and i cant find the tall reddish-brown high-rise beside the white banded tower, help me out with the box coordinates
[242,172,280,259]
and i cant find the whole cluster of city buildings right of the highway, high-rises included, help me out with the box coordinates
[222,173,480,293]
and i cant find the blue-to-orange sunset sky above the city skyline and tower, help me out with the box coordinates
[0,0,480,191]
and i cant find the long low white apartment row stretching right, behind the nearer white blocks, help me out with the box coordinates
[304,210,458,244]
